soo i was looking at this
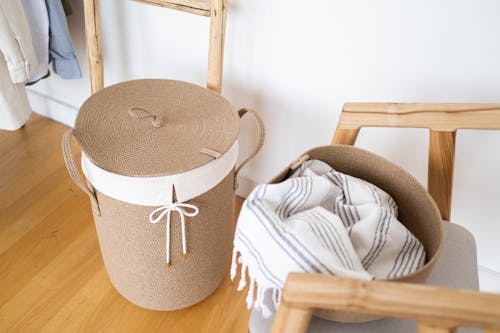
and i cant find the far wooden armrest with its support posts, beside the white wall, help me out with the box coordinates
[332,103,500,221]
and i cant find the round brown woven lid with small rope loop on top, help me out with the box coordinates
[75,79,239,177]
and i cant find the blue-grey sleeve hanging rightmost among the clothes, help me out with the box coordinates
[46,0,82,79]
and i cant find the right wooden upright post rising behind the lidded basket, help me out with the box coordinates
[207,0,227,93]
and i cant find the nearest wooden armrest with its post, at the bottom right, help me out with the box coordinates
[272,273,500,333]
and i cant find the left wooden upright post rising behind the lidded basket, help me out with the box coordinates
[83,0,104,94]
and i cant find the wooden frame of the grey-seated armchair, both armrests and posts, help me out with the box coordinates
[272,103,500,333]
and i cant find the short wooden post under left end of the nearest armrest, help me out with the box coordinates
[271,301,312,333]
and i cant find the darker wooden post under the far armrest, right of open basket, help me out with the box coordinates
[427,130,456,221]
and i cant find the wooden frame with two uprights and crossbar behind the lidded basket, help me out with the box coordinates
[83,0,227,93]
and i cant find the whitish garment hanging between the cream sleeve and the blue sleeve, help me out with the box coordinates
[21,0,49,85]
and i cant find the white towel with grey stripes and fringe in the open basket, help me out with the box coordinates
[231,160,425,317]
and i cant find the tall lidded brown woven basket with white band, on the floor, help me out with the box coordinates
[62,80,264,310]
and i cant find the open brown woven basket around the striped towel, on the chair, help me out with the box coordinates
[270,145,443,322]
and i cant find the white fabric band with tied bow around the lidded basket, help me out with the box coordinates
[82,141,239,267]
